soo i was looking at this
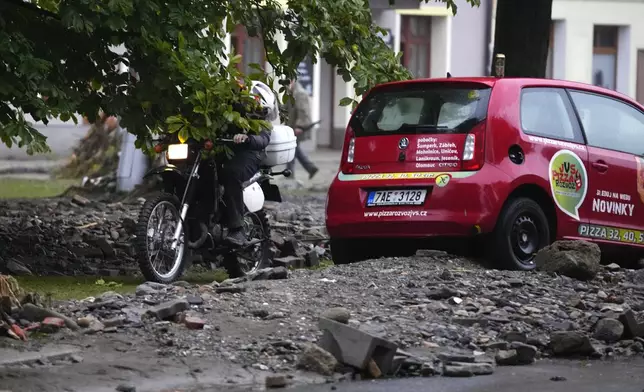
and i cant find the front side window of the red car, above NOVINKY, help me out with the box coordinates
[571,91,644,155]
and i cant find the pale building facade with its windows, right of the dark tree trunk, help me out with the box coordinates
[547,0,644,103]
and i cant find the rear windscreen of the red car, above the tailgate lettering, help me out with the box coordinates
[352,84,492,136]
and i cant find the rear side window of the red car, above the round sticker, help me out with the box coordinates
[521,87,583,143]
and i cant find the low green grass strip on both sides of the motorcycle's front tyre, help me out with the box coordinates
[15,270,228,300]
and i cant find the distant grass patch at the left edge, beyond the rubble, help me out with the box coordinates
[0,178,80,199]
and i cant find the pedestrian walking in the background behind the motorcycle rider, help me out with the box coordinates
[286,80,318,179]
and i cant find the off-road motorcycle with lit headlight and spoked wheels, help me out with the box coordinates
[135,128,294,283]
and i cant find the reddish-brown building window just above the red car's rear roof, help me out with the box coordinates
[400,16,431,78]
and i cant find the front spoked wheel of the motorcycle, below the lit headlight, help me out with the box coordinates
[134,193,187,284]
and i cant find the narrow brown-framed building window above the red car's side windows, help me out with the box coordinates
[593,26,619,90]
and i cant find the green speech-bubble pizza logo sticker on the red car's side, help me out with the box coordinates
[548,150,588,220]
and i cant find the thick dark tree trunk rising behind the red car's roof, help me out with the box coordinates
[492,0,552,78]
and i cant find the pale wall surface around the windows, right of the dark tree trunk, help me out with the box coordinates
[552,0,644,97]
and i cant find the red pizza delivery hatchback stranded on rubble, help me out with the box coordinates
[326,78,644,270]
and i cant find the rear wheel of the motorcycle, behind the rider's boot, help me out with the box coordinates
[223,210,271,278]
